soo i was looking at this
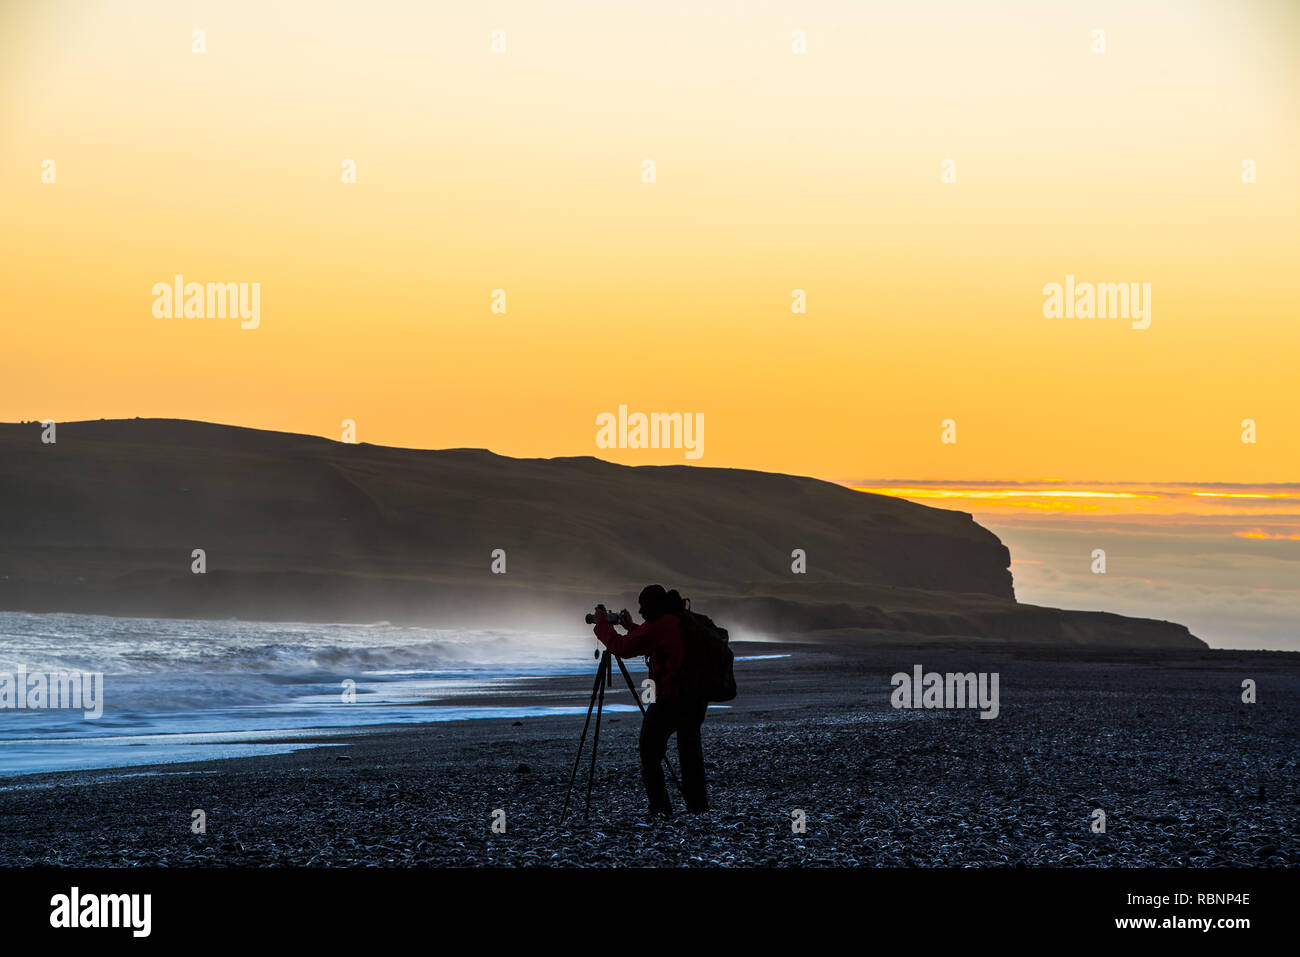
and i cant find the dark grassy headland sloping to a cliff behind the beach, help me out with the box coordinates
[0,419,1204,648]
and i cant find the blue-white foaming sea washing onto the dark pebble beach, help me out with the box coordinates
[0,612,644,776]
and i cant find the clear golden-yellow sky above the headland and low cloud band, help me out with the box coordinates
[0,0,1300,485]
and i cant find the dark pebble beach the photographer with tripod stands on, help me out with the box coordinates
[0,637,1300,867]
